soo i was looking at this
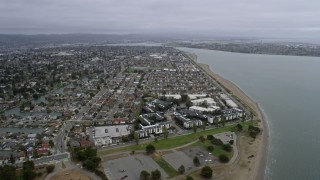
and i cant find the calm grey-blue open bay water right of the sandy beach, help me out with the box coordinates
[179,48,320,180]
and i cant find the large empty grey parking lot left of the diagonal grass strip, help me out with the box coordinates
[104,154,167,180]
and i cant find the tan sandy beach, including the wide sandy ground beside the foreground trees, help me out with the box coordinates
[186,54,269,180]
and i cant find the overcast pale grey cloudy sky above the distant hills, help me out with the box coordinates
[0,0,320,37]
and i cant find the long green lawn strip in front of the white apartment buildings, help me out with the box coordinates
[98,122,256,156]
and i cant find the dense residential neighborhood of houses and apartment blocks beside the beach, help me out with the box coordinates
[0,46,250,178]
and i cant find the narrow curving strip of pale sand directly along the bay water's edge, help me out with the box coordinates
[185,52,269,180]
